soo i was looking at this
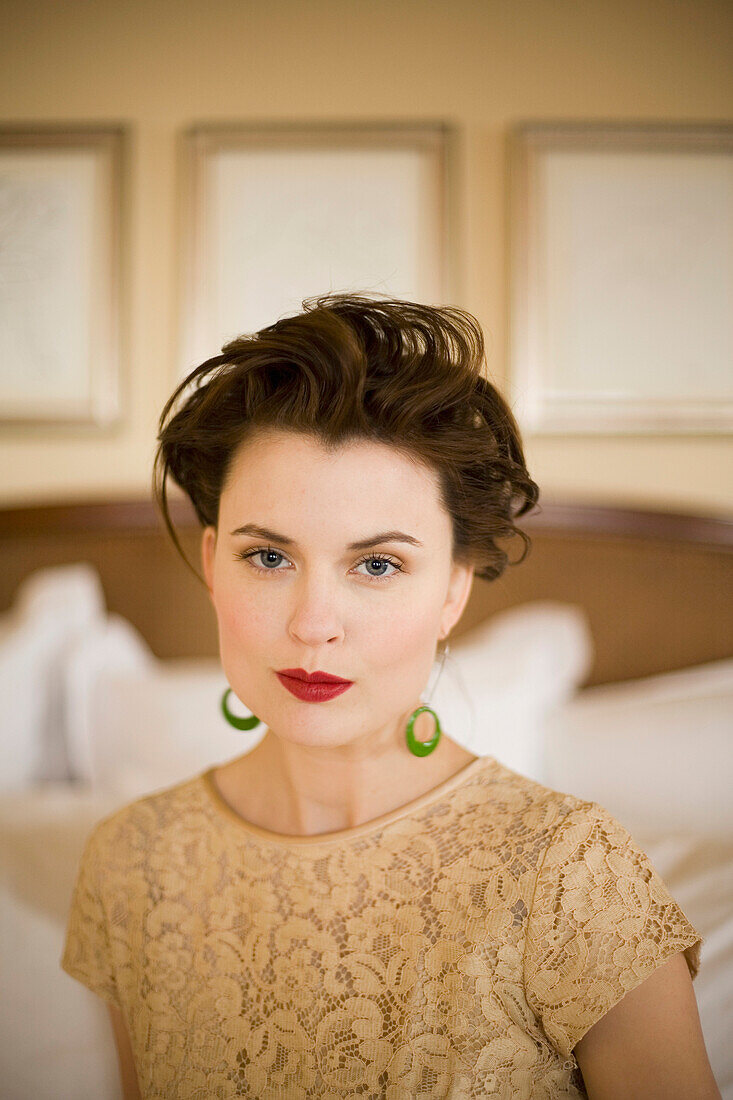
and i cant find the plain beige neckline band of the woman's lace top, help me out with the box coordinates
[198,756,496,848]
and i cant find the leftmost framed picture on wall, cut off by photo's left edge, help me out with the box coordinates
[0,127,123,426]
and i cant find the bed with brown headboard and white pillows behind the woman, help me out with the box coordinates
[0,497,733,1100]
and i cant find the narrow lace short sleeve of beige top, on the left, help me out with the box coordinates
[61,828,120,1007]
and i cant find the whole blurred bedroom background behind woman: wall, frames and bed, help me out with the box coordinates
[0,0,733,1100]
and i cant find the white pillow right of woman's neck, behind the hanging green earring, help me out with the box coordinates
[425,600,593,782]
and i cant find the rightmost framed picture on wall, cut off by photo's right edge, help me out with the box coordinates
[508,122,733,433]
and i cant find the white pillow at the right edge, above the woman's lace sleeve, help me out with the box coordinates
[544,659,733,837]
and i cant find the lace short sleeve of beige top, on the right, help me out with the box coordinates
[524,802,702,1058]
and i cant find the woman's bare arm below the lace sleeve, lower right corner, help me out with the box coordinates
[573,952,721,1100]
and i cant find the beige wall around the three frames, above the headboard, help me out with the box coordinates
[0,0,733,515]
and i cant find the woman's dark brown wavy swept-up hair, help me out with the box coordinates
[153,294,539,581]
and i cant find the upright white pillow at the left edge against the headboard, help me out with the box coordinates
[0,562,105,791]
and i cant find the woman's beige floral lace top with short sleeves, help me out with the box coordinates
[61,757,702,1100]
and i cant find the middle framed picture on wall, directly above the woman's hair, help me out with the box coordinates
[178,123,456,376]
